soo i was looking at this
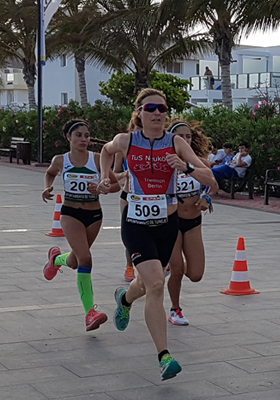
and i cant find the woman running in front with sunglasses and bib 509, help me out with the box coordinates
[98,89,218,380]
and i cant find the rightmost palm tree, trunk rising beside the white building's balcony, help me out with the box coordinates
[162,0,279,109]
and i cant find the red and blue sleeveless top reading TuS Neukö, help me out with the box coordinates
[127,131,177,205]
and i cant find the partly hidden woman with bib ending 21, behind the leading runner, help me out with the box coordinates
[167,118,213,325]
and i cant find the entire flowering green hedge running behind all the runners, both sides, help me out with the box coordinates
[0,100,280,190]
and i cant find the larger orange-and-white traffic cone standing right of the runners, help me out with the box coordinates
[221,237,260,296]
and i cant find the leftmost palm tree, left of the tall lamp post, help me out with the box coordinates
[0,0,38,109]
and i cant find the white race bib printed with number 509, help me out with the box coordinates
[126,193,168,226]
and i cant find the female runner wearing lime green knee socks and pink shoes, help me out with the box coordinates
[42,119,120,331]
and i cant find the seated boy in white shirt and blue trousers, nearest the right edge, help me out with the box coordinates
[212,142,252,179]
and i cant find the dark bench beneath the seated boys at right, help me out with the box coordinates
[218,159,255,199]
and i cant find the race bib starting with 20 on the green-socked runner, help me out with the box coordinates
[64,172,99,201]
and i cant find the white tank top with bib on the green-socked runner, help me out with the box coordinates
[62,151,100,203]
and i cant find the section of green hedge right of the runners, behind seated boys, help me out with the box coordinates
[185,102,280,191]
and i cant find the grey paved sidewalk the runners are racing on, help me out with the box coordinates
[0,162,280,400]
